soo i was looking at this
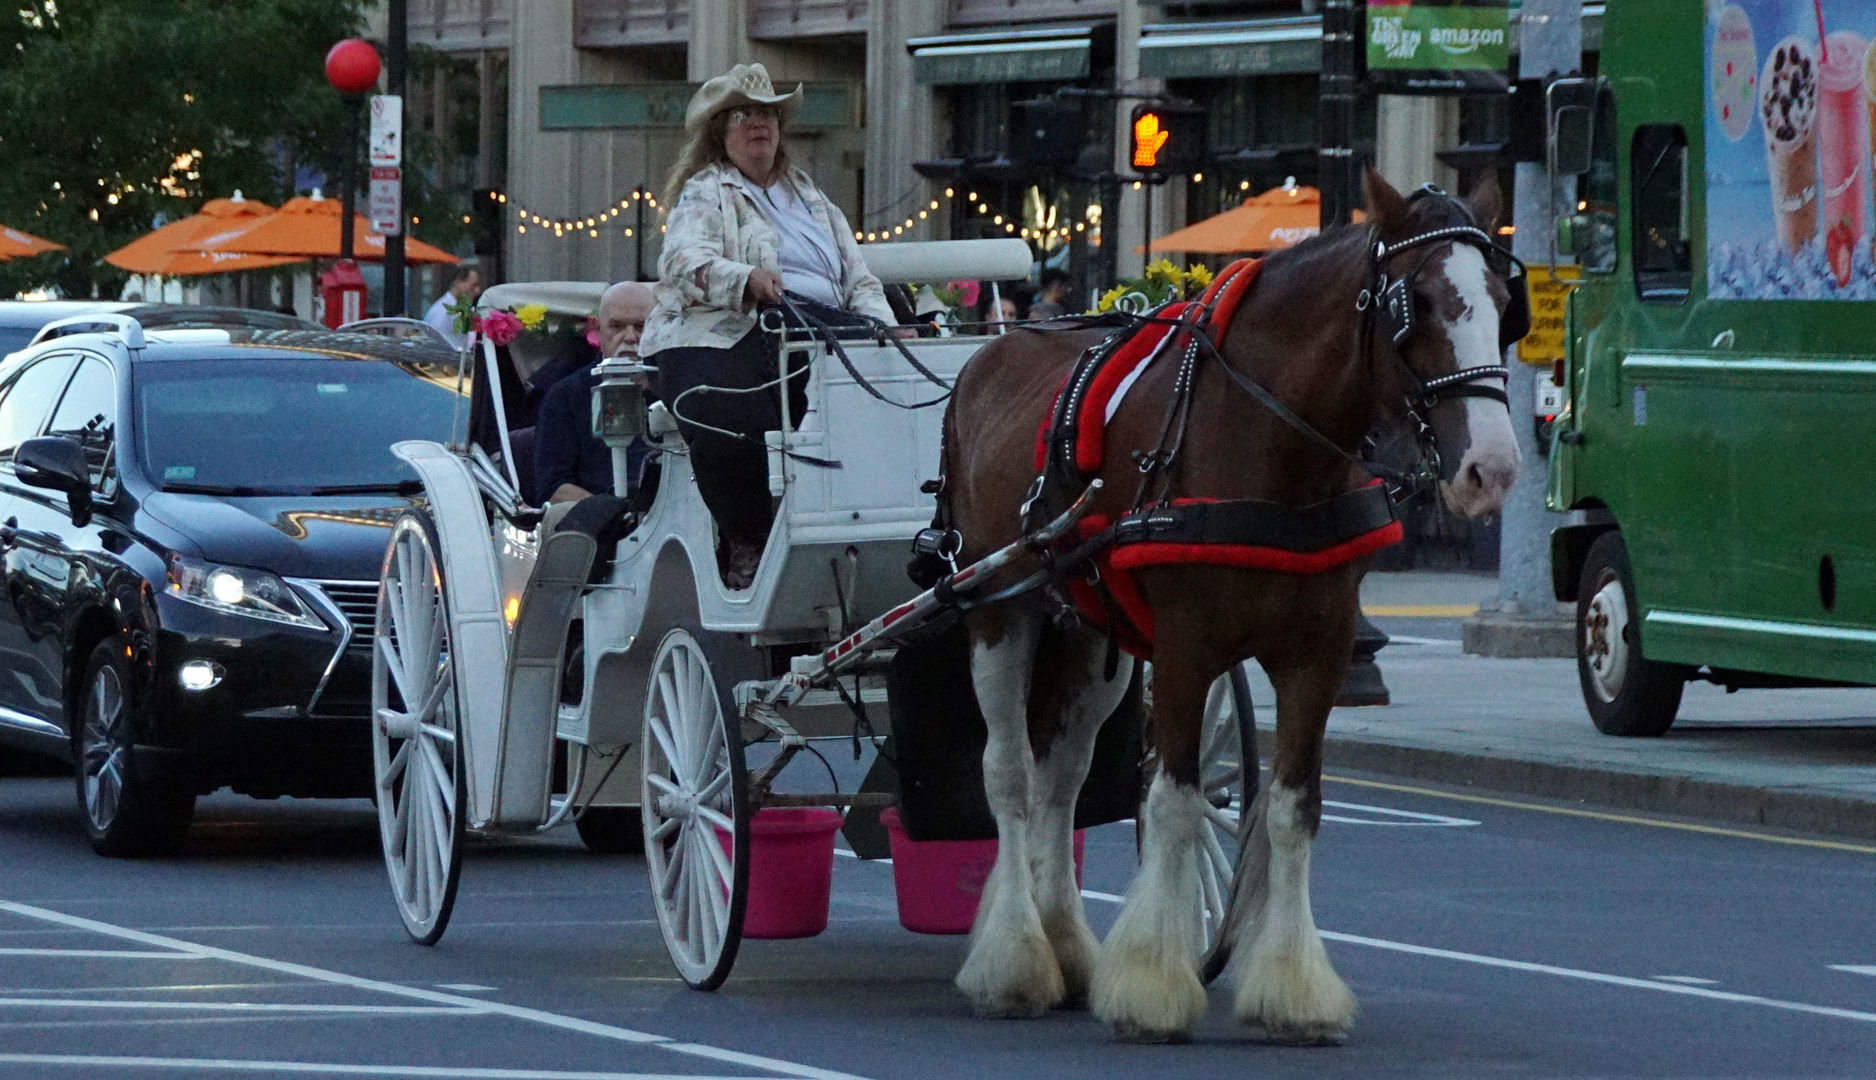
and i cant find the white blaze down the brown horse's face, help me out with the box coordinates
[1439,244,1521,518]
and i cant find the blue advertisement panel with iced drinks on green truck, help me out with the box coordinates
[1718,0,1876,300]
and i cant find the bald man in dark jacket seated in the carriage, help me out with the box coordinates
[535,281,657,503]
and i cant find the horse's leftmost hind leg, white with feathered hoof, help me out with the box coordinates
[957,609,1066,1016]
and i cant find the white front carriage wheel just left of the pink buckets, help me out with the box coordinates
[640,630,749,990]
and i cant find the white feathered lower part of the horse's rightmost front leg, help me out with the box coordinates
[1236,782,1354,1043]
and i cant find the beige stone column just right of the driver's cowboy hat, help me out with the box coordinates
[854,0,946,240]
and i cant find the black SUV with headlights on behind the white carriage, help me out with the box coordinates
[0,315,469,855]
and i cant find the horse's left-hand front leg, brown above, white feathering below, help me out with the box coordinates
[1092,645,1218,1043]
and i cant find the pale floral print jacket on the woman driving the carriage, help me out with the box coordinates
[640,161,897,356]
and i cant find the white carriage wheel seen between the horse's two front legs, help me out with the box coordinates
[1199,664,1257,983]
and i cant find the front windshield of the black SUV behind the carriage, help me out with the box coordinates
[133,358,469,495]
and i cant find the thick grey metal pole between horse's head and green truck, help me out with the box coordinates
[1461,0,1583,656]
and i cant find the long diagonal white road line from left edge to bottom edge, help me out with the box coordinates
[0,900,874,1080]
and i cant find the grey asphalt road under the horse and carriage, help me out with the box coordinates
[0,753,1876,1080]
